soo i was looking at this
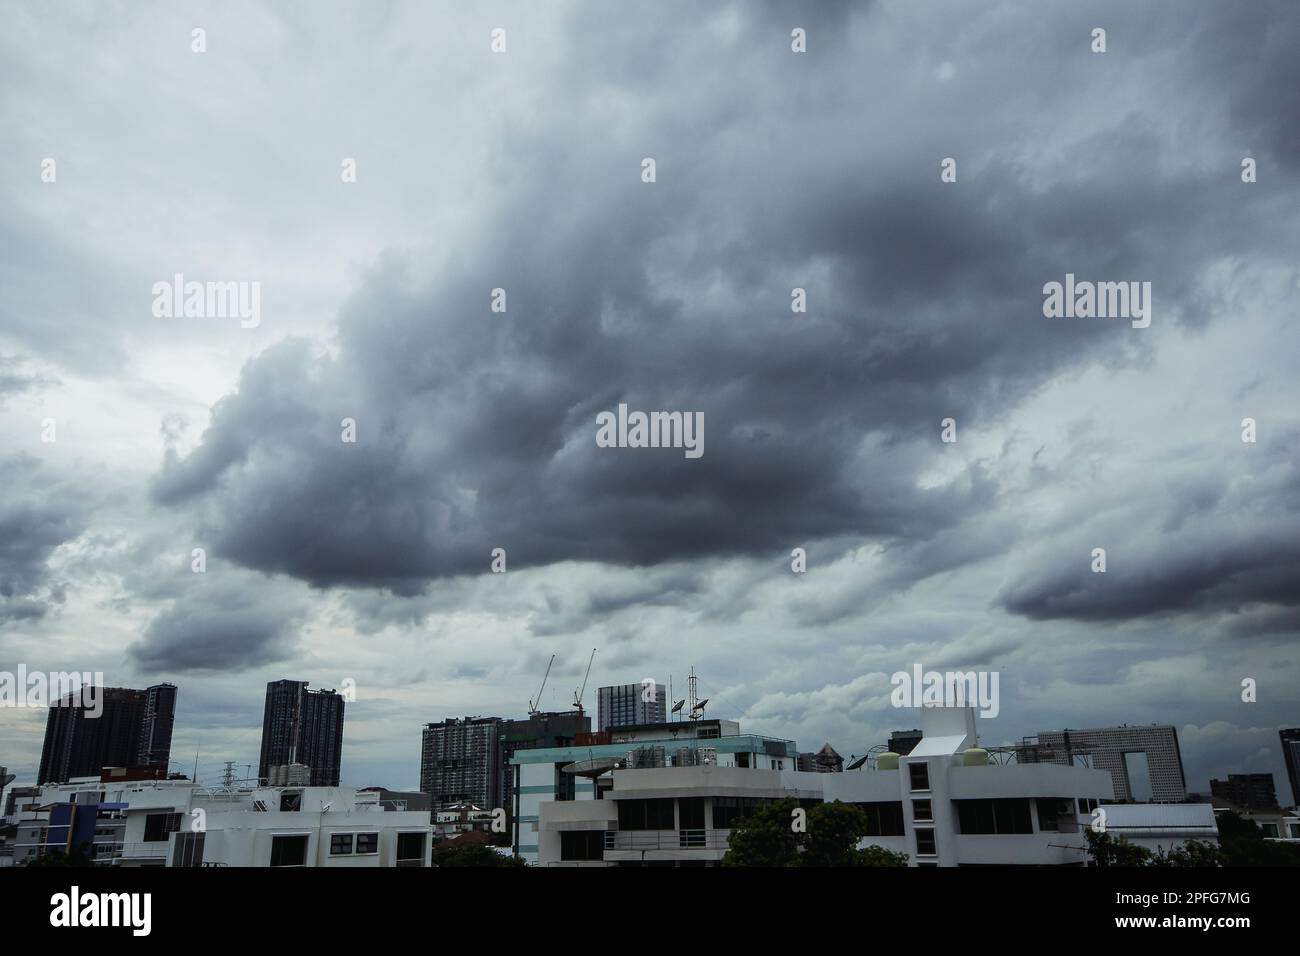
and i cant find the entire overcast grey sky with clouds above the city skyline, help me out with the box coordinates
[0,0,1300,800]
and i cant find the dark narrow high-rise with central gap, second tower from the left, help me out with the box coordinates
[257,680,345,787]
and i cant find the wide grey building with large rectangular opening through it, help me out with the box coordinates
[1037,724,1187,804]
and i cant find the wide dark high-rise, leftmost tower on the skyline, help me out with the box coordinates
[36,684,176,783]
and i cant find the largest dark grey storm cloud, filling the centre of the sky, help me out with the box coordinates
[153,1,1295,606]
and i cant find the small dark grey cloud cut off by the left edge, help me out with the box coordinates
[0,455,86,622]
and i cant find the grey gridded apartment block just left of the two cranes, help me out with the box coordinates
[420,717,504,810]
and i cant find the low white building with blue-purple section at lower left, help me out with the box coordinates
[16,778,433,868]
